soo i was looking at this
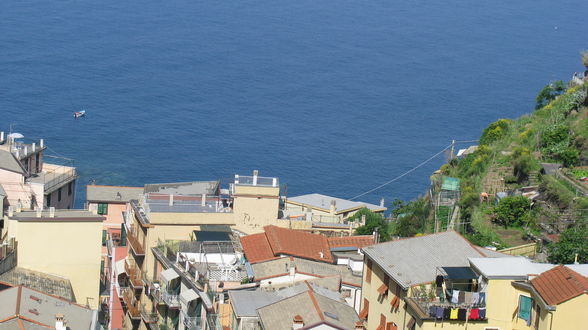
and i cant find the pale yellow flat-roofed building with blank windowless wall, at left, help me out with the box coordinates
[2,207,104,309]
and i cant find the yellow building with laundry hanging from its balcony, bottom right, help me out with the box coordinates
[360,232,588,330]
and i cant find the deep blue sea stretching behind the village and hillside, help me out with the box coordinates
[0,0,588,205]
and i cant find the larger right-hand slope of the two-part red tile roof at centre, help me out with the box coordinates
[263,226,333,263]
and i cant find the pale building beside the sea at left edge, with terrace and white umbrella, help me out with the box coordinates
[0,132,78,210]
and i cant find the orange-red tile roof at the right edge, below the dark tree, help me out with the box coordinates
[531,265,588,306]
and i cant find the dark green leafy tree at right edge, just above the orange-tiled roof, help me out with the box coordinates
[547,228,588,264]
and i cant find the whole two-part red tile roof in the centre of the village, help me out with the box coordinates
[241,226,334,263]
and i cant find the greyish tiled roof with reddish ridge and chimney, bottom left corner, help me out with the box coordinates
[0,283,100,330]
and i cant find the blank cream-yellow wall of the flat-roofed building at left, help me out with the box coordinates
[9,221,102,309]
